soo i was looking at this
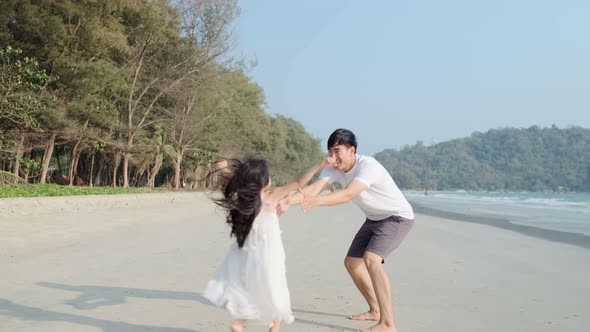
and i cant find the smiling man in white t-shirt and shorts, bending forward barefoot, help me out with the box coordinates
[281,129,414,332]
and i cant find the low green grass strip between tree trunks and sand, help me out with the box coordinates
[0,184,154,198]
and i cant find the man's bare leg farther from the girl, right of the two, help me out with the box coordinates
[363,251,397,332]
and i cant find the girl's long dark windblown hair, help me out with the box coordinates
[209,158,270,248]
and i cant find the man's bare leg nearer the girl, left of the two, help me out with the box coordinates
[344,256,380,320]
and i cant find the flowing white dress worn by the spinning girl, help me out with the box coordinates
[203,201,294,324]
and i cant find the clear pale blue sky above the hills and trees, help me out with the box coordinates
[233,0,590,155]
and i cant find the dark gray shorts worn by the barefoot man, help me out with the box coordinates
[346,216,414,260]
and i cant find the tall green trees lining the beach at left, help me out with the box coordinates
[0,0,322,188]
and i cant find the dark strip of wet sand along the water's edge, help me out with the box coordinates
[408,199,590,250]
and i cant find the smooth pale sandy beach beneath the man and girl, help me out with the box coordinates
[0,193,590,332]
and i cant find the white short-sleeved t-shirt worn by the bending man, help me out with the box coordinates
[319,154,414,220]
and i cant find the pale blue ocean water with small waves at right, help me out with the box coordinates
[404,191,590,235]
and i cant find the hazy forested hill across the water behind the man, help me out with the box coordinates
[375,126,590,191]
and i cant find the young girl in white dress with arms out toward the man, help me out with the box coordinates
[203,159,328,332]
